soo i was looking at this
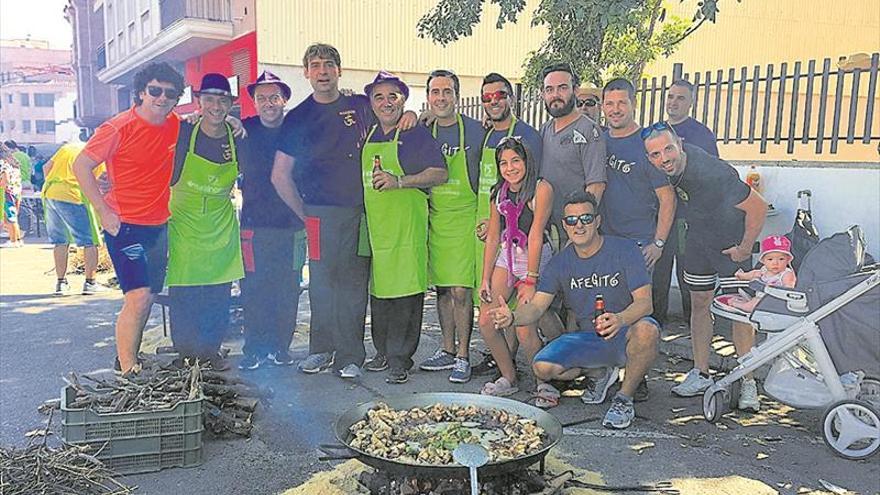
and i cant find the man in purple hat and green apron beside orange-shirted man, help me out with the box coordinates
[166,73,244,369]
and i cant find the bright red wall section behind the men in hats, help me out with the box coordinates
[178,31,257,118]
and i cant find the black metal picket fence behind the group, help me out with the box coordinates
[460,53,880,154]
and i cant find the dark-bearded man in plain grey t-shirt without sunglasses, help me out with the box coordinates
[541,63,606,235]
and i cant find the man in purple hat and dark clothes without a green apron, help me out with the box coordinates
[238,71,305,370]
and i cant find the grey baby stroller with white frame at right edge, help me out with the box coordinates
[703,226,880,459]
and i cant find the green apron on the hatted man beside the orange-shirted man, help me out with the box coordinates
[166,124,244,286]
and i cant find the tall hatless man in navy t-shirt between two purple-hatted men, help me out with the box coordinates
[272,43,417,378]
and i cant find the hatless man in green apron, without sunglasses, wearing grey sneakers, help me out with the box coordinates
[419,70,485,383]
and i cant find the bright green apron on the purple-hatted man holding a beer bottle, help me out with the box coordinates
[361,125,428,299]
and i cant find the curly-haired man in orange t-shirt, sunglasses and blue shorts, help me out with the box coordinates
[73,63,183,372]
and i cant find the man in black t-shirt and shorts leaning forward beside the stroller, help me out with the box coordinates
[643,122,767,411]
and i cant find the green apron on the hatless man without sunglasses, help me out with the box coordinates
[428,115,477,288]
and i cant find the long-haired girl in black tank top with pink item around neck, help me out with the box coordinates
[479,137,553,396]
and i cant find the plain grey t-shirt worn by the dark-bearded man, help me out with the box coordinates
[541,115,606,222]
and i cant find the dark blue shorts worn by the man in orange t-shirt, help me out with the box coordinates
[104,223,168,294]
